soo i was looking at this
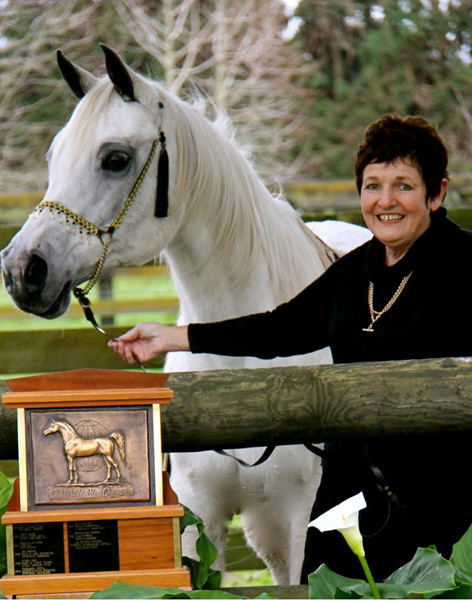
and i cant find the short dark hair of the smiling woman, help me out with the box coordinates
[355,115,449,200]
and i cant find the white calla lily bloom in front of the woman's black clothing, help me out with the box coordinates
[308,492,367,556]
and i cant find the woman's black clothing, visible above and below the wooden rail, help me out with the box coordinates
[189,208,472,581]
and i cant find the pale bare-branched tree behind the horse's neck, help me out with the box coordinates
[113,0,305,183]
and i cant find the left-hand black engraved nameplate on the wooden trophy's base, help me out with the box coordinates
[13,523,65,575]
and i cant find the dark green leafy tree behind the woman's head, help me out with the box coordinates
[298,0,472,177]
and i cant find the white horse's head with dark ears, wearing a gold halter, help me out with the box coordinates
[1,47,186,318]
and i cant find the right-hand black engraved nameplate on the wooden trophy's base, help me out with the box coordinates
[67,521,120,573]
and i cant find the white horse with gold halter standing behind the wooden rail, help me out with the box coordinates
[2,48,370,585]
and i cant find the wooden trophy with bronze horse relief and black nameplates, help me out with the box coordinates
[0,369,191,597]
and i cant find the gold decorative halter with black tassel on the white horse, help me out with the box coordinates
[35,131,169,370]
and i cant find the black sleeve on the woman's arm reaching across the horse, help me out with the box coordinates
[188,265,336,359]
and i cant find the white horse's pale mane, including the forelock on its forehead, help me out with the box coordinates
[58,77,328,303]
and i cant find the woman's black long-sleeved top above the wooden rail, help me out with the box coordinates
[189,208,472,363]
